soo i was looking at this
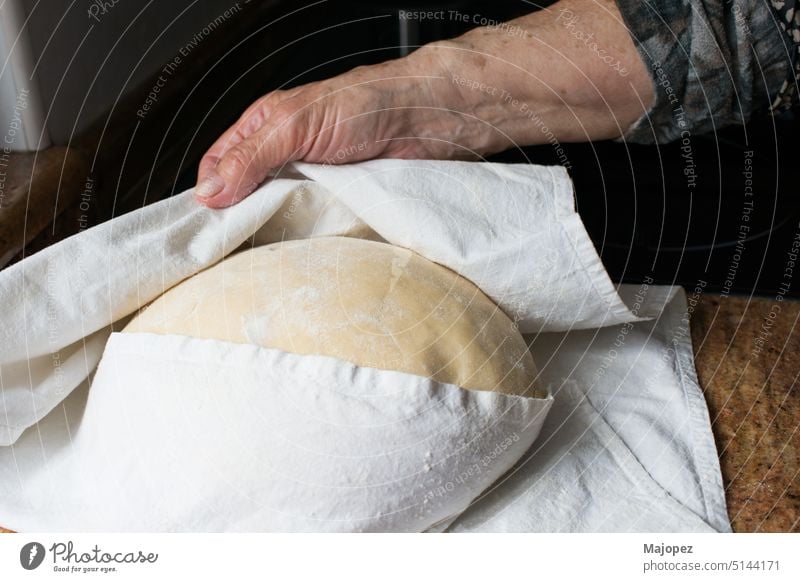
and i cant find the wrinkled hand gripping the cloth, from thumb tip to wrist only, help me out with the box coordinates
[195,53,469,208]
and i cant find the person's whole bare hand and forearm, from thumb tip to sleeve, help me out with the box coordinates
[195,0,654,208]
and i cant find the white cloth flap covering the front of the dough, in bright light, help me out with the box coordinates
[0,333,552,531]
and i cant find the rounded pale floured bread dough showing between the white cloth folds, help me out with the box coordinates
[124,237,543,397]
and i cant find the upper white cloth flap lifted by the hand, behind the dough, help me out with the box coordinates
[0,160,636,444]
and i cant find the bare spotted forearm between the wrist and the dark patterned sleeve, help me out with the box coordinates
[400,0,653,153]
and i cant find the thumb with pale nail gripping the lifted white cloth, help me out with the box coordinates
[195,124,299,208]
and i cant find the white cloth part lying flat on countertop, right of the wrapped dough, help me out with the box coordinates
[450,286,730,532]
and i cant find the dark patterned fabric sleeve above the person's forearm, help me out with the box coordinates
[617,0,800,143]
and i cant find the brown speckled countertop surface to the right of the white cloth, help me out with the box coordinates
[692,295,800,532]
